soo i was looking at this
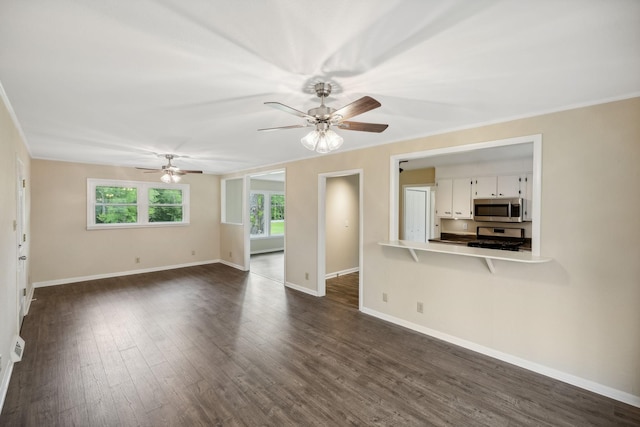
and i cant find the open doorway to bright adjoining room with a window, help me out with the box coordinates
[246,170,286,284]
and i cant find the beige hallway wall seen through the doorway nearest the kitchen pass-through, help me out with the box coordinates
[325,175,360,277]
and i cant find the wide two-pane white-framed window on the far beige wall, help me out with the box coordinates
[87,179,189,229]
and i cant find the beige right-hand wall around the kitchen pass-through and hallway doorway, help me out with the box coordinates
[221,98,640,402]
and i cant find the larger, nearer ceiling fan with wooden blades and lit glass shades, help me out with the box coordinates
[258,83,389,153]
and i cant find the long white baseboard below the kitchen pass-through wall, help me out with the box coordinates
[362,307,640,408]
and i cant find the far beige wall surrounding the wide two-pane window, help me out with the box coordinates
[32,160,220,284]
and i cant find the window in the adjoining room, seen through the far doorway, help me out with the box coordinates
[249,191,285,238]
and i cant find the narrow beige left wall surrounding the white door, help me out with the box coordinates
[0,85,32,390]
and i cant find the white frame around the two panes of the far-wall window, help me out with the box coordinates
[87,178,190,230]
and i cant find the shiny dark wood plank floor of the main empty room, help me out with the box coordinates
[0,264,640,426]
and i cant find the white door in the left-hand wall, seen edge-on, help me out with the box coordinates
[16,159,28,326]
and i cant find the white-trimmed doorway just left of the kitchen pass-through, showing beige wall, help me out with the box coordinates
[317,169,363,310]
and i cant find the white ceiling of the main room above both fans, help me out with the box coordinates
[0,0,640,173]
